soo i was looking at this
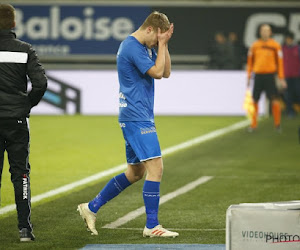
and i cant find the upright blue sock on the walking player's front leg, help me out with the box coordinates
[143,180,160,228]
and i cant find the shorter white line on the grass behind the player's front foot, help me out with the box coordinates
[102,176,213,228]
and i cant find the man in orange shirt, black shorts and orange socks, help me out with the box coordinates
[247,24,286,132]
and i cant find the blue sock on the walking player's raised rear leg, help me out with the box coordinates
[89,173,131,213]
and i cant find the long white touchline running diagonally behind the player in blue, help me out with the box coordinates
[0,120,249,215]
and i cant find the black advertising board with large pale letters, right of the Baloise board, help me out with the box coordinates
[153,4,300,55]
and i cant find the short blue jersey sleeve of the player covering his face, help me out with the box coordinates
[132,47,155,75]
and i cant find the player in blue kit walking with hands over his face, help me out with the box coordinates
[78,11,178,237]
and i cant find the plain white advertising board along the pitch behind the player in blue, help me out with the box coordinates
[32,70,265,115]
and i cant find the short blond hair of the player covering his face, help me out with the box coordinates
[140,11,170,32]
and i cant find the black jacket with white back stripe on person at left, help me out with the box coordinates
[0,30,47,119]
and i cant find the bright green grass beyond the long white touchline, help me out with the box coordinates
[1,116,243,207]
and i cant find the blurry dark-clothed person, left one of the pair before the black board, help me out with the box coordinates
[209,32,234,70]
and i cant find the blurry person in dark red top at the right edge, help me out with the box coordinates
[282,32,300,117]
